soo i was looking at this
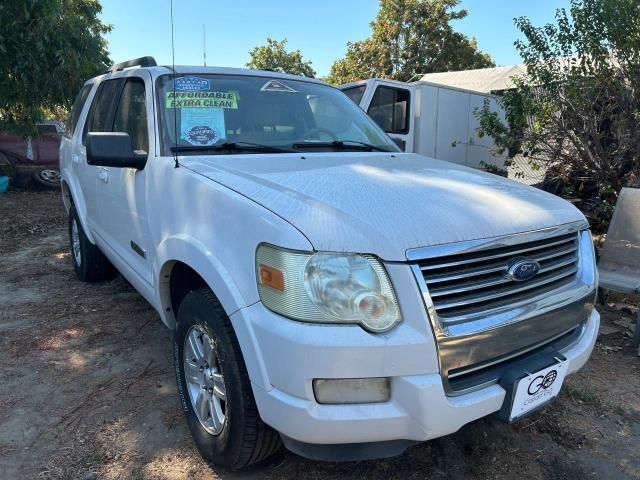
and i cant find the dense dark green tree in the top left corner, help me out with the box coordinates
[0,0,111,135]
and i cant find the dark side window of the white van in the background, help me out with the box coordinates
[367,87,411,133]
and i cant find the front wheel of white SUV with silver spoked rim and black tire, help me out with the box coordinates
[173,288,281,470]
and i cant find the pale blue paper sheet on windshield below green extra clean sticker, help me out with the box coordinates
[180,108,226,146]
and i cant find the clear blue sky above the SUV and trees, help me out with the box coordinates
[102,0,569,77]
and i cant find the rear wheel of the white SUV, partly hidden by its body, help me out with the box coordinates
[69,204,116,283]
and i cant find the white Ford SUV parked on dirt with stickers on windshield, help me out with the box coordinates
[61,57,599,468]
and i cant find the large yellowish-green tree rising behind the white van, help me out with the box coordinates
[328,0,495,84]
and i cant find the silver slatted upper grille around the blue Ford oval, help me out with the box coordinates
[418,233,579,325]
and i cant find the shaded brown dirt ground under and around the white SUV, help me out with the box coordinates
[0,192,640,480]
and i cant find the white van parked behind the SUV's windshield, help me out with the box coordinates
[338,78,506,171]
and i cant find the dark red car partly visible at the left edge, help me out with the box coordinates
[0,122,64,188]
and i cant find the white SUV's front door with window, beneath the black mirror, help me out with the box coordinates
[96,72,153,284]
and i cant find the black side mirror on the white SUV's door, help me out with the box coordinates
[87,132,148,170]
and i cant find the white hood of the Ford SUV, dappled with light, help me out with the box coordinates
[180,152,584,261]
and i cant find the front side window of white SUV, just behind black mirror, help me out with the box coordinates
[113,78,149,152]
